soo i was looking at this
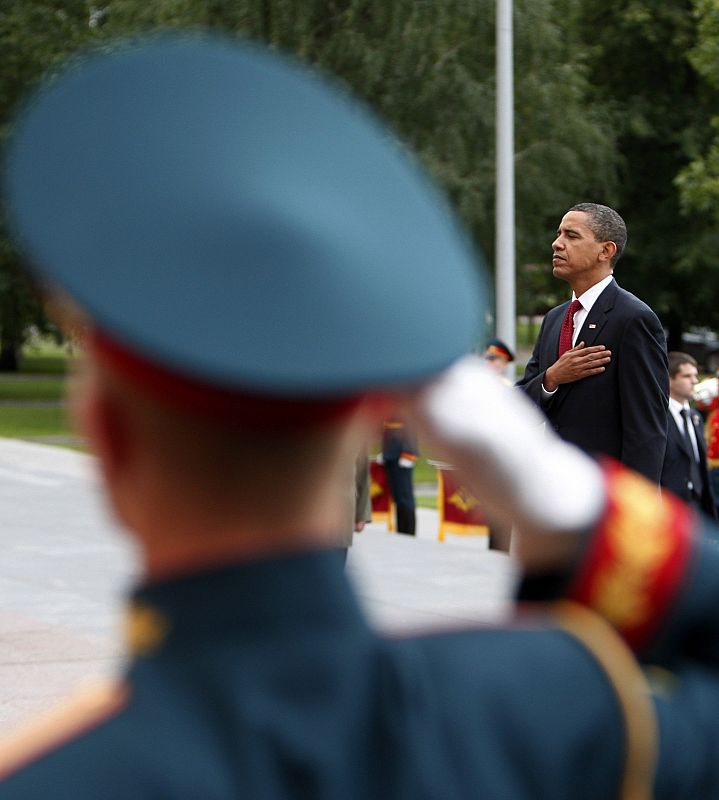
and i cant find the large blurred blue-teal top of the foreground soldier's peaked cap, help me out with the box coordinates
[5,34,485,397]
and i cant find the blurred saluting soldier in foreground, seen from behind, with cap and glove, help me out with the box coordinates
[0,38,719,800]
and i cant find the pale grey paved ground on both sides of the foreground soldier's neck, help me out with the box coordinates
[0,439,514,733]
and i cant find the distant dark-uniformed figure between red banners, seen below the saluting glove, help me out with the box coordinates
[382,419,419,536]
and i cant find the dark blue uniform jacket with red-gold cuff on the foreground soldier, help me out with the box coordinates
[0,462,719,800]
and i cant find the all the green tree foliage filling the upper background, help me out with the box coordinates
[0,0,719,368]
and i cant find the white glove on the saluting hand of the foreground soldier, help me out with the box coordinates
[412,356,605,533]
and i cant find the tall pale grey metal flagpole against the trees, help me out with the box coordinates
[495,0,516,376]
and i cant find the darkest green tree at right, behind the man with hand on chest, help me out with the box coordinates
[580,0,719,348]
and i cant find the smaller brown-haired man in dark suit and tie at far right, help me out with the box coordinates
[661,352,716,519]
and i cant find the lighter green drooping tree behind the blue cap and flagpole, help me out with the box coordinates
[0,0,618,362]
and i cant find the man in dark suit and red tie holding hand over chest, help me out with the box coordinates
[517,203,669,483]
